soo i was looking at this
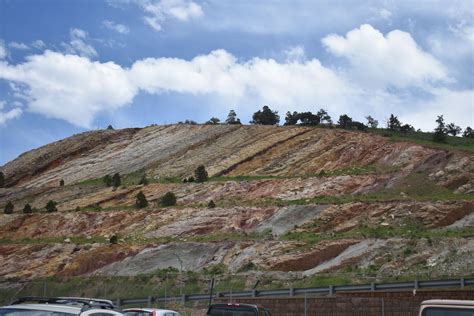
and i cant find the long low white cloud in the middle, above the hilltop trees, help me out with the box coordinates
[130,50,352,111]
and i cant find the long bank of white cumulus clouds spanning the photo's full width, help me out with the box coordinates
[0,26,473,129]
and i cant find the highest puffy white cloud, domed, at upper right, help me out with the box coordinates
[322,24,451,88]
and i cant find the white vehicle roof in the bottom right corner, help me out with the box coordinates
[420,300,474,316]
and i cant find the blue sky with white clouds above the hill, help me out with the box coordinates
[0,0,474,165]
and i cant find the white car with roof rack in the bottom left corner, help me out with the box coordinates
[0,296,122,316]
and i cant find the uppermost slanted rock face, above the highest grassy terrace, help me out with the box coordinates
[2,125,474,187]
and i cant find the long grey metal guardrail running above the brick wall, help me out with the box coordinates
[116,278,474,306]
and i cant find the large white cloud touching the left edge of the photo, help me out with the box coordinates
[0,51,136,127]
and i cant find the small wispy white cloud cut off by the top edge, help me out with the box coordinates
[138,0,204,31]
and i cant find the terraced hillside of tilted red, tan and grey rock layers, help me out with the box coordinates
[0,124,474,298]
